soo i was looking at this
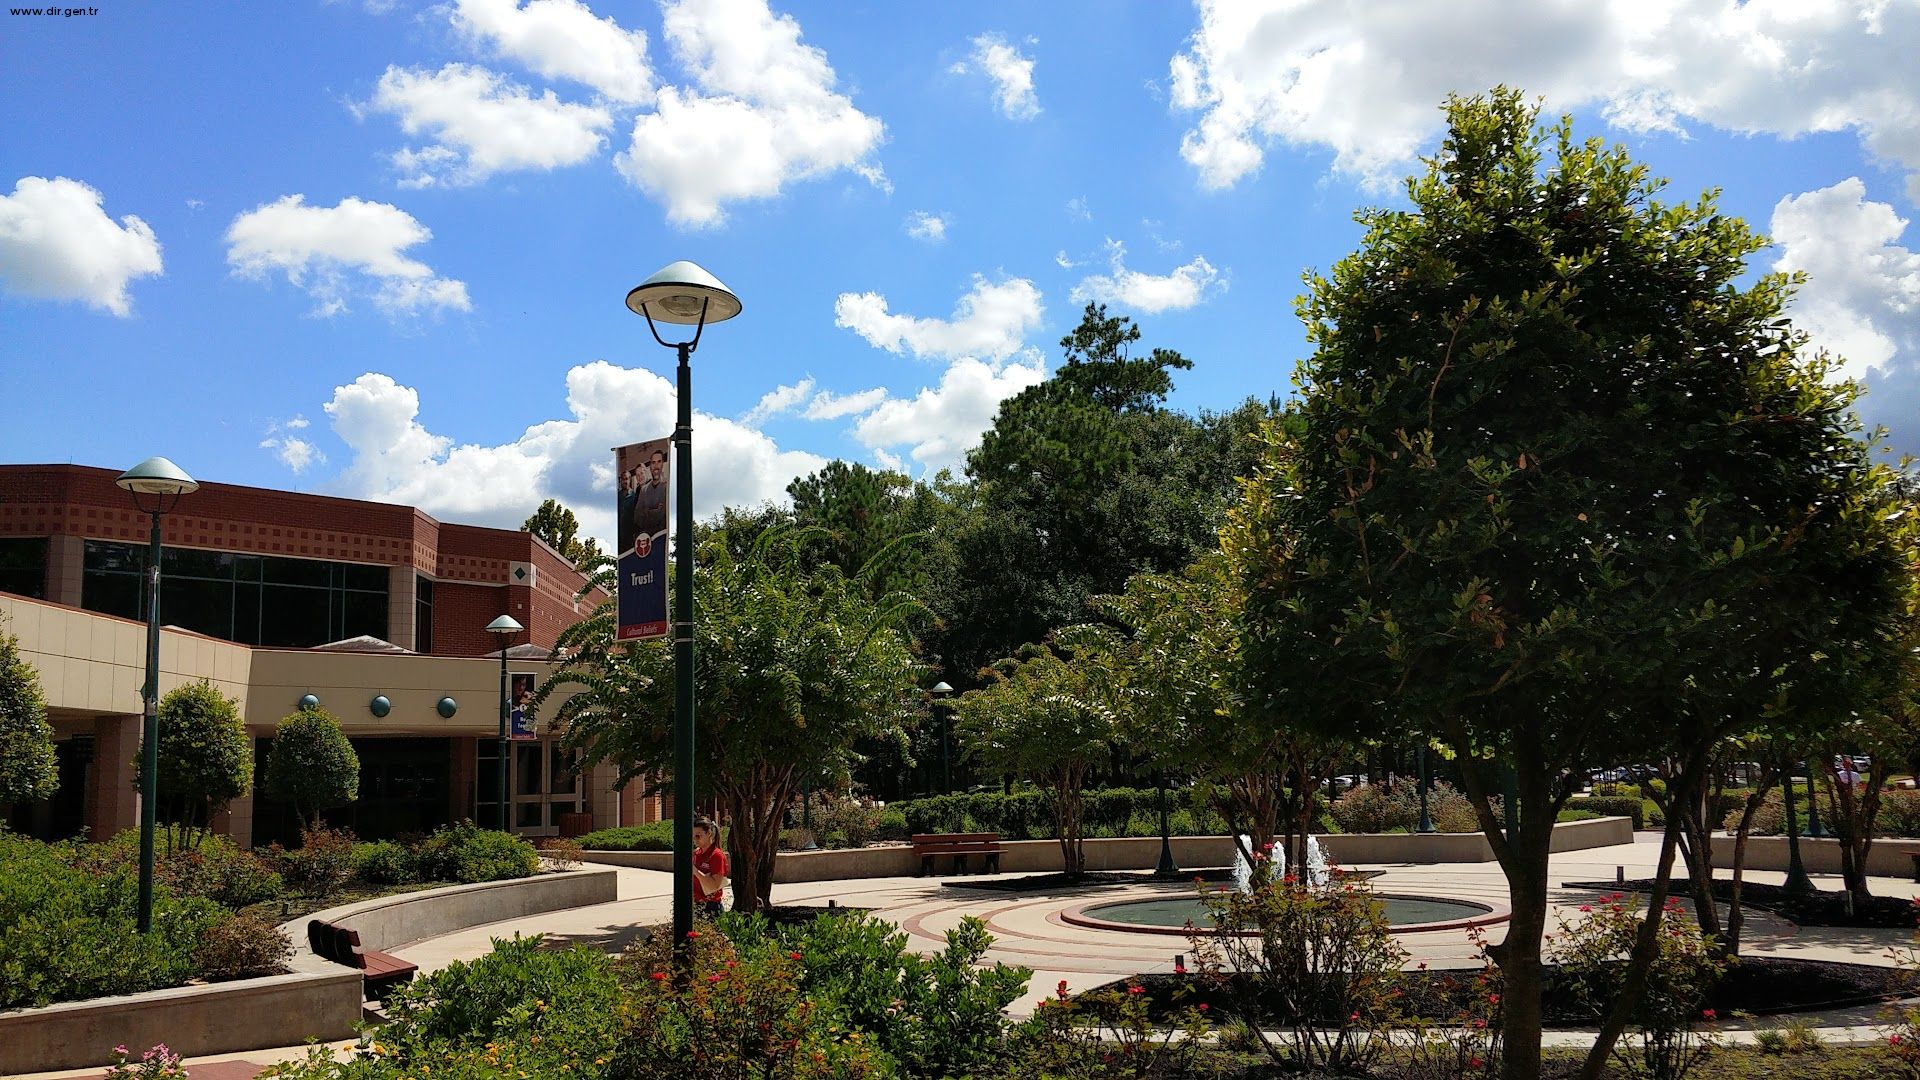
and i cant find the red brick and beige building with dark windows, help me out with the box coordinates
[0,465,659,842]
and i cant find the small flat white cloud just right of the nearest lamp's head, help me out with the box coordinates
[833,275,1044,359]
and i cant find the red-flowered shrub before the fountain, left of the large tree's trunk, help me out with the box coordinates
[1190,851,1407,1072]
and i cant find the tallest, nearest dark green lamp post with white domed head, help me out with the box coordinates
[626,259,745,949]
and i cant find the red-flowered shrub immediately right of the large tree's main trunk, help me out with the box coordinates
[1551,894,1730,1080]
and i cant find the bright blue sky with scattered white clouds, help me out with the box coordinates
[0,0,1920,532]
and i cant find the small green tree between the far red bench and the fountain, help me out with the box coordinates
[954,646,1119,878]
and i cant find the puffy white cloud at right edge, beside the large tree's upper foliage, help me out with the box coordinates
[1772,177,1920,452]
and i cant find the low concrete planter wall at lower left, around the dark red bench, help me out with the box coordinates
[0,871,618,1076]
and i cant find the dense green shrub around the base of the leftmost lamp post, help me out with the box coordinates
[0,830,227,1009]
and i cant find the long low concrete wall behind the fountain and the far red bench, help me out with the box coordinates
[586,817,1634,884]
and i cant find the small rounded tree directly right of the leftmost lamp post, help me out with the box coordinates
[132,680,253,847]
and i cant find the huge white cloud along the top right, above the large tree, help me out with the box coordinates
[1171,0,1920,200]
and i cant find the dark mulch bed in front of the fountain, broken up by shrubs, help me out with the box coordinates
[1106,957,1912,1028]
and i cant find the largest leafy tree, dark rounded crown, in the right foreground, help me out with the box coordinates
[1235,90,1878,1078]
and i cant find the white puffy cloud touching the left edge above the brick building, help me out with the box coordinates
[0,177,161,317]
